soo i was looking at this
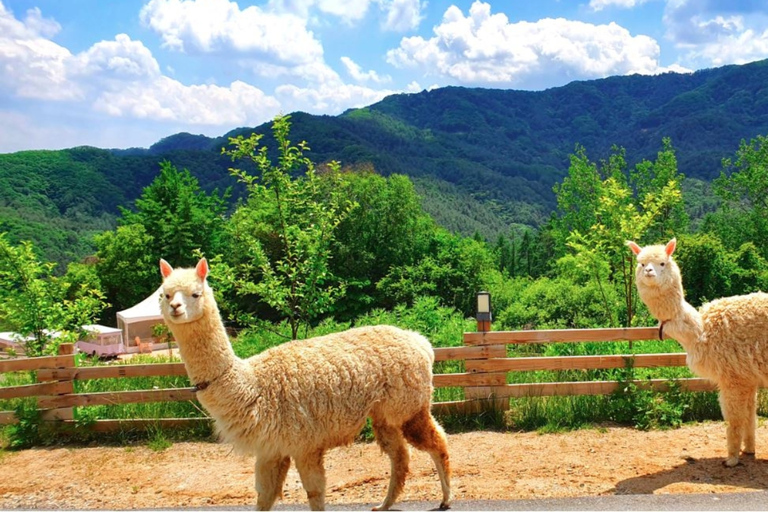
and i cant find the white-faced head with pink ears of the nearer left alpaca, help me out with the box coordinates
[160,258,212,325]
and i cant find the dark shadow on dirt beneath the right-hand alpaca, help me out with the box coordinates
[609,455,768,494]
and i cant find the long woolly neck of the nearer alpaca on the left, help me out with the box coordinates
[171,305,238,383]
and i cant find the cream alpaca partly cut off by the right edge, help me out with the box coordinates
[627,239,768,466]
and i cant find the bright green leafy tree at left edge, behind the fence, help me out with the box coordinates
[0,233,106,356]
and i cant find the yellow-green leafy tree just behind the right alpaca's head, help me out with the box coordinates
[555,141,687,326]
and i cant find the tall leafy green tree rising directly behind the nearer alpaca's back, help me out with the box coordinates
[222,116,354,339]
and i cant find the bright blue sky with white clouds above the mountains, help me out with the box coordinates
[0,0,768,152]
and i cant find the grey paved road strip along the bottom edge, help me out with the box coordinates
[141,491,768,511]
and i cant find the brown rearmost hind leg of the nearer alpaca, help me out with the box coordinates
[403,407,452,510]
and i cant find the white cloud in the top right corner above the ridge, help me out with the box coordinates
[664,0,768,67]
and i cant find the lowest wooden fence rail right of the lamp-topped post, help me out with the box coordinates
[488,378,717,398]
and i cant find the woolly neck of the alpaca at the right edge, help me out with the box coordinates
[640,283,704,353]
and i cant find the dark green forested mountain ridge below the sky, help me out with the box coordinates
[0,61,768,268]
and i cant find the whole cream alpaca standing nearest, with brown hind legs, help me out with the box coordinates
[160,259,451,510]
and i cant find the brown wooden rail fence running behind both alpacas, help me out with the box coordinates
[0,327,715,431]
